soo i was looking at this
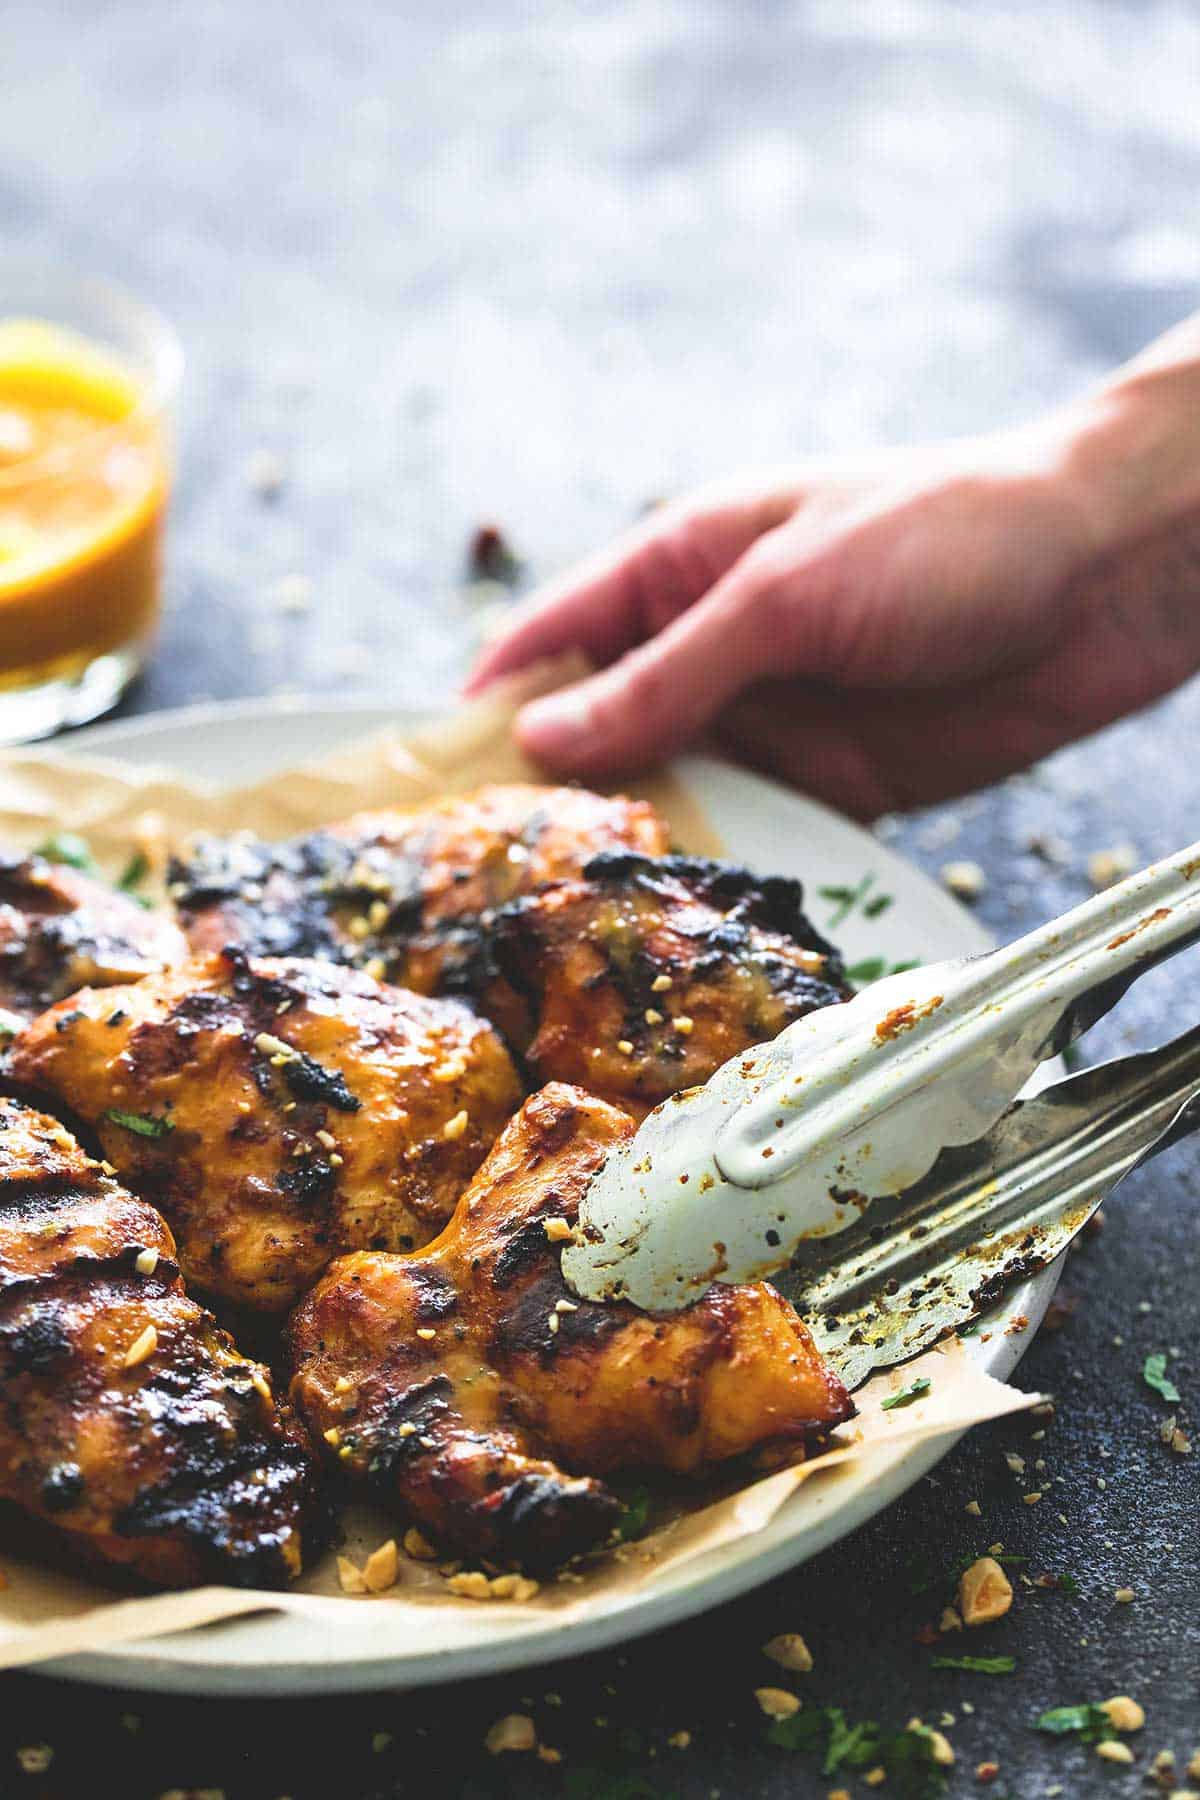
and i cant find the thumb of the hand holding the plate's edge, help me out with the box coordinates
[516,533,798,774]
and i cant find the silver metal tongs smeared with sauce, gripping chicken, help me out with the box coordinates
[563,844,1200,1384]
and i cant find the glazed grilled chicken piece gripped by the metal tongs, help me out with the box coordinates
[288,1084,853,1568]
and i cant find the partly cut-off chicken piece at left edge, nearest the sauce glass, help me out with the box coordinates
[0,851,187,1031]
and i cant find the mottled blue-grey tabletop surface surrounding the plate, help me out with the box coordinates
[0,0,1200,1800]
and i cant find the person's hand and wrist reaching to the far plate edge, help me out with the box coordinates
[468,334,1200,817]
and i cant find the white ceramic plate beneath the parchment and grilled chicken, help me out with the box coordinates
[32,700,1058,1694]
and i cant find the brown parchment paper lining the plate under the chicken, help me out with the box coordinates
[0,662,1040,1669]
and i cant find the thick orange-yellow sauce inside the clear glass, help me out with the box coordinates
[0,319,169,689]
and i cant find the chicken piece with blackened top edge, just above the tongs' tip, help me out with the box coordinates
[484,853,851,1118]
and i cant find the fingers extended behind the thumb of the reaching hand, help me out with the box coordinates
[464,482,795,695]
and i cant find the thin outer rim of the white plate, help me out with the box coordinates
[16,695,1061,1697]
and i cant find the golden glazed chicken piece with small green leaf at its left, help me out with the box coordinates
[9,949,522,1312]
